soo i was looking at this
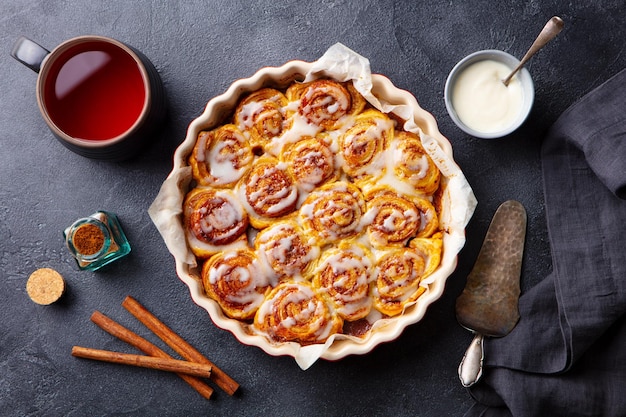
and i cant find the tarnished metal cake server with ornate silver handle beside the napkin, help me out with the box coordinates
[456,200,526,387]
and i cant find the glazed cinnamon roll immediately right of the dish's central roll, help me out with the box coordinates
[366,192,421,248]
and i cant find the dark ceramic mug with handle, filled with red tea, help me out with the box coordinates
[11,36,166,160]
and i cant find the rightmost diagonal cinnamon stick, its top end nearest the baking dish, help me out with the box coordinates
[122,296,239,395]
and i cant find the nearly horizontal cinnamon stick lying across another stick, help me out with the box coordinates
[72,346,211,378]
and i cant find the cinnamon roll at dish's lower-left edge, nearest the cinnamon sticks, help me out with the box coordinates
[202,249,271,320]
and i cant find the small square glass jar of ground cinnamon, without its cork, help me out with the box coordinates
[63,211,130,271]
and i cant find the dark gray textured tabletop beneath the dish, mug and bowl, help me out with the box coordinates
[0,0,626,417]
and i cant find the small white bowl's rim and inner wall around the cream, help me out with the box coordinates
[444,49,535,139]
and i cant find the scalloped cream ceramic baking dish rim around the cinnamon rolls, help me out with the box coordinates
[150,57,476,369]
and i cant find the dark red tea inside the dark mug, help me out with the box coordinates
[43,42,146,140]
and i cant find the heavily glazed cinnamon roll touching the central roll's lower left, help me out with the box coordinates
[254,220,320,278]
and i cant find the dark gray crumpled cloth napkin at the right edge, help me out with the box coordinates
[466,70,626,417]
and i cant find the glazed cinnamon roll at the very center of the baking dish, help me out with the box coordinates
[299,181,365,245]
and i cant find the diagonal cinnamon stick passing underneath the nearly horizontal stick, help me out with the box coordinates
[91,311,213,400]
